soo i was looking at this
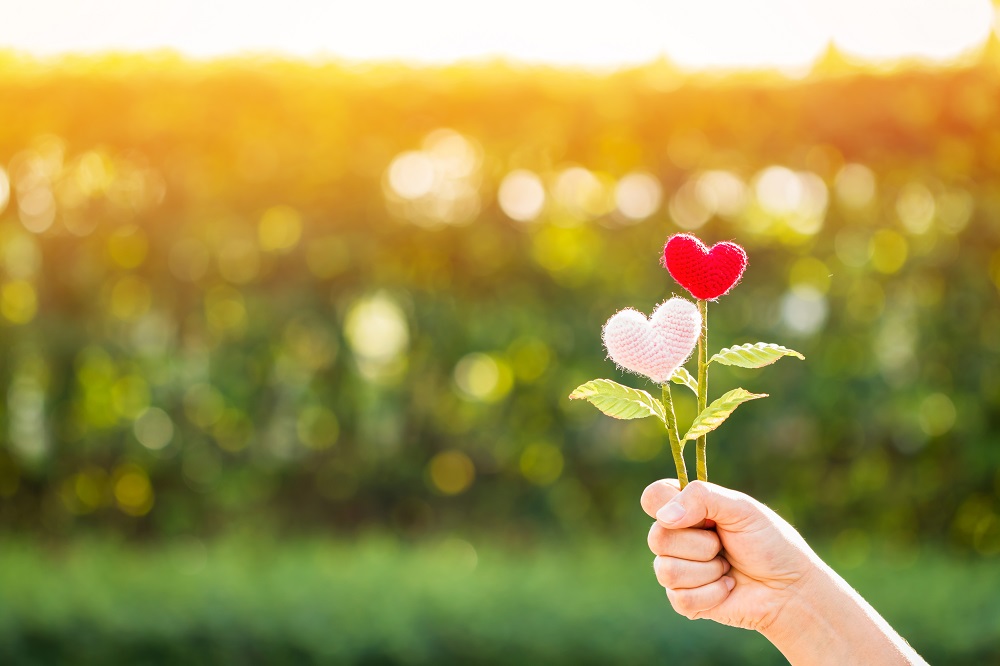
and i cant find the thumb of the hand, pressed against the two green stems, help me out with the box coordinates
[656,481,757,529]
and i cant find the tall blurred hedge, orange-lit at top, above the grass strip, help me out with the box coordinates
[0,50,1000,558]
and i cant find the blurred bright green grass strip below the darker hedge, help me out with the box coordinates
[0,537,1000,665]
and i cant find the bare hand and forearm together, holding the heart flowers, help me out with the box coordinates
[642,479,926,666]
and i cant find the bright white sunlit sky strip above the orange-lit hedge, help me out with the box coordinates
[0,0,994,69]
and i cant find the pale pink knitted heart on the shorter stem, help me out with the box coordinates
[601,298,701,384]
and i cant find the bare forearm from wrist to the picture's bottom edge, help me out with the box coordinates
[761,562,926,666]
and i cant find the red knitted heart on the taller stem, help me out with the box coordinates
[663,234,747,301]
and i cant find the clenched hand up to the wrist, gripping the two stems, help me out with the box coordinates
[642,479,822,631]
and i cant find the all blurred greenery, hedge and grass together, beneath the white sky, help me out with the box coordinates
[0,3,1000,664]
